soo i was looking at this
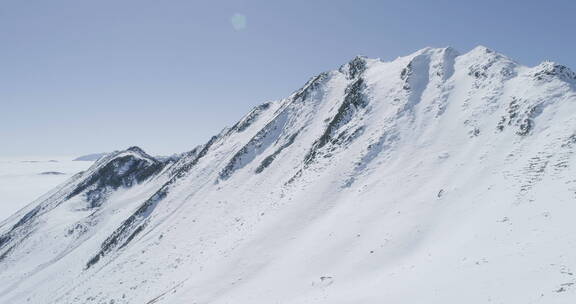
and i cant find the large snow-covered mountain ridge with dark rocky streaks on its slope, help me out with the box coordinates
[0,47,576,304]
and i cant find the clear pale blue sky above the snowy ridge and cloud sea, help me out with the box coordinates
[0,0,576,156]
